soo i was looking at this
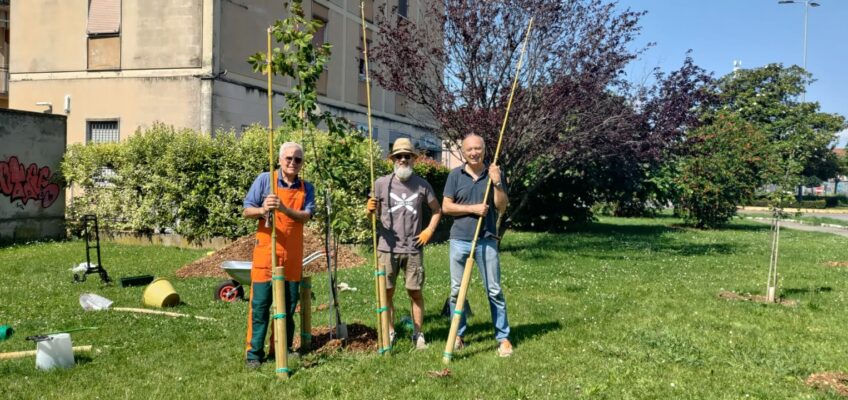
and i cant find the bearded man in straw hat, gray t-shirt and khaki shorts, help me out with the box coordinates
[366,138,442,350]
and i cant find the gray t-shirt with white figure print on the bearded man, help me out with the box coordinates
[374,174,436,254]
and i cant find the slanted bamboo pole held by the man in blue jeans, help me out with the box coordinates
[442,18,533,364]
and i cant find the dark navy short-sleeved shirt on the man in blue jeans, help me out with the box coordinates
[444,164,506,242]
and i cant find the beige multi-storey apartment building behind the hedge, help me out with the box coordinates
[9,0,441,158]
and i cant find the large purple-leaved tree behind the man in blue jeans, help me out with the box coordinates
[373,0,708,231]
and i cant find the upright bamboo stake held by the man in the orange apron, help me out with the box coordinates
[265,27,289,379]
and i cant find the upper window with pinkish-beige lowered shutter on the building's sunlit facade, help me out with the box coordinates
[87,0,121,71]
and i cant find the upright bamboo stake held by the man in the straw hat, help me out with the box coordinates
[359,0,392,355]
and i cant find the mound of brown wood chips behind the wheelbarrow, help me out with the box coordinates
[176,227,367,278]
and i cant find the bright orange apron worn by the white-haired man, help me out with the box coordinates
[250,171,306,282]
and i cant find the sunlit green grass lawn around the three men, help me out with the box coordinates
[0,218,848,399]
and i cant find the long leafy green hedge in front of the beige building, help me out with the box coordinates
[62,123,386,242]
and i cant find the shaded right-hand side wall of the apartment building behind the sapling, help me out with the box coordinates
[212,0,441,153]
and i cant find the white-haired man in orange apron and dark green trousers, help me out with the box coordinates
[242,142,315,368]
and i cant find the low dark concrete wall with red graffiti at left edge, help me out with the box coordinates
[0,110,66,240]
